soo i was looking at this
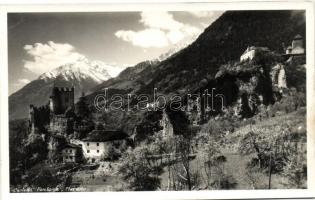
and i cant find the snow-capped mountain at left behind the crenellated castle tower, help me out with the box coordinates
[9,59,115,119]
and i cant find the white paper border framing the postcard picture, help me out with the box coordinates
[0,1,315,200]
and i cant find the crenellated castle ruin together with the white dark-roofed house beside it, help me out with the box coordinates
[29,87,133,163]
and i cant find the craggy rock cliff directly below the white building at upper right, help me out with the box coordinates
[216,51,287,118]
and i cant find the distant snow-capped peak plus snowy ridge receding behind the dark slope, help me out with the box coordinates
[9,34,195,119]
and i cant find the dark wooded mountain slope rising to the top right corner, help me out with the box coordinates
[89,10,305,99]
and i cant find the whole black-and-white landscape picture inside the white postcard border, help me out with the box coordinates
[2,1,314,198]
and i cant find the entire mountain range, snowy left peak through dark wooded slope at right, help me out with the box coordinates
[9,10,305,119]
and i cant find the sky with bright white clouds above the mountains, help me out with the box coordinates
[8,11,222,94]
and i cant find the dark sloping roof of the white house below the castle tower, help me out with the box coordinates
[82,130,128,142]
